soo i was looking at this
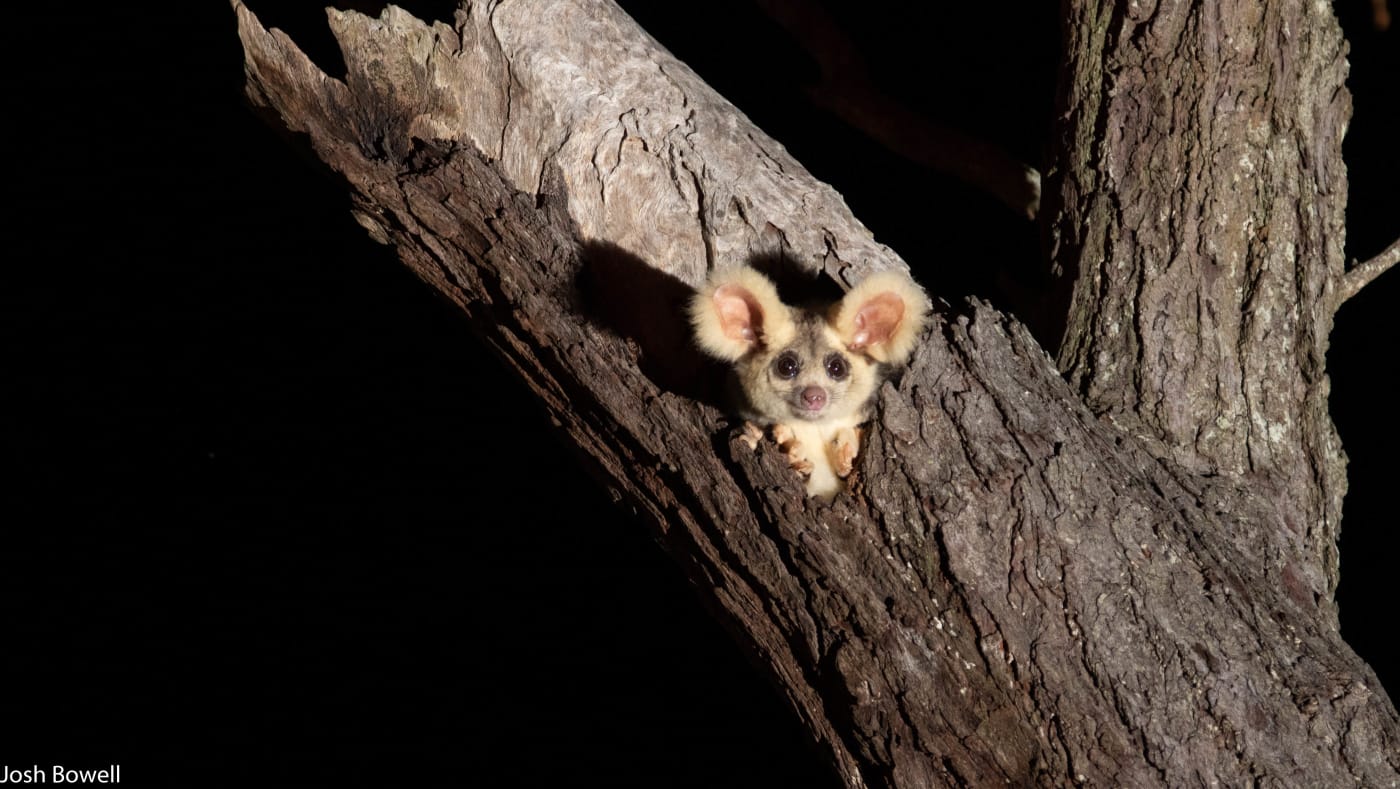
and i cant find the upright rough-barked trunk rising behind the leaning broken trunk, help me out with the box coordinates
[1050,0,1351,625]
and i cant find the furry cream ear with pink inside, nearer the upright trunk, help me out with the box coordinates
[832,271,930,364]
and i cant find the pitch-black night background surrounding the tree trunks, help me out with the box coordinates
[0,0,1400,786]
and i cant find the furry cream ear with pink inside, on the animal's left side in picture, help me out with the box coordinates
[690,266,797,361]
